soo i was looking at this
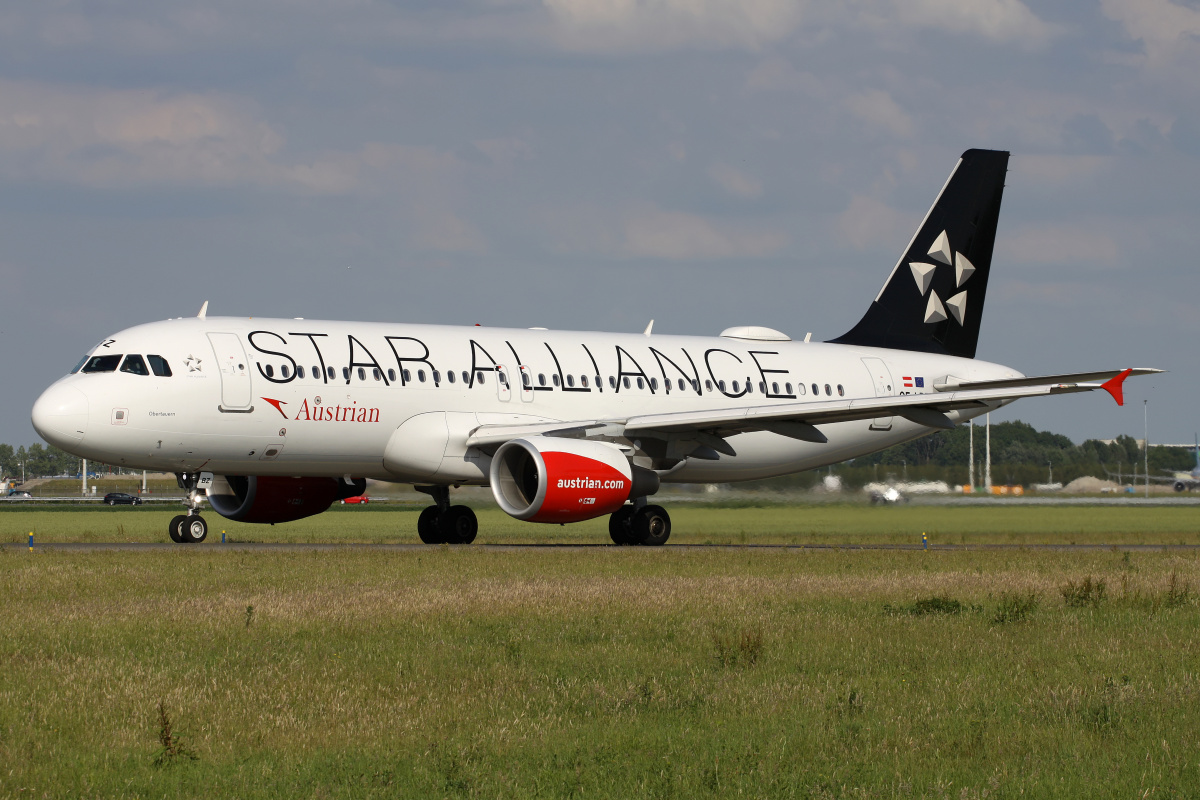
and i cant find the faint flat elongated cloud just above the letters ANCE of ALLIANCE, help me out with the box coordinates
[623,207,788,260]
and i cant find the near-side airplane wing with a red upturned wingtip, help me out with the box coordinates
[467,368,1160,458]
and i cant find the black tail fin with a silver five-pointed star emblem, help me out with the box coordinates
[832,150,1008,359]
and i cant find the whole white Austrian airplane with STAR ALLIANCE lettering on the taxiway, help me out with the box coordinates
[32,150,1159,545]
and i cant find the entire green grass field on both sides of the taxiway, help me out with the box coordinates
[0,506,1200,798]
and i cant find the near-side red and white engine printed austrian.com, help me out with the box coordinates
[490,437,659,523]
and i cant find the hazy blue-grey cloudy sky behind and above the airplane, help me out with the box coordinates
[0,0,1200,445]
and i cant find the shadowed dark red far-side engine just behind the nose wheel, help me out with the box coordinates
[208,475,366,523]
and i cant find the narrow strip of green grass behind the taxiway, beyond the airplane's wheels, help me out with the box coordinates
[0,503,1200,546]
